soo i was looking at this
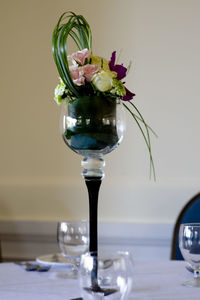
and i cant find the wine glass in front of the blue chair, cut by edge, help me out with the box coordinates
[179,223,200,287]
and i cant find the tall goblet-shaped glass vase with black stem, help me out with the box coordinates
[61,95,125,290]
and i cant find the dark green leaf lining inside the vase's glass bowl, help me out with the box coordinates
[64,96,118,150]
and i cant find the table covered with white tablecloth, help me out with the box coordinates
[0,261,200,300]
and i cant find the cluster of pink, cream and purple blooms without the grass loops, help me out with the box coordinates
[54,48,135,104]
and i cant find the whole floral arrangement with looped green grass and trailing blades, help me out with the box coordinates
[52,12,155,176]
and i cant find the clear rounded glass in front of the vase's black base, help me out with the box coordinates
[79,251,133,300]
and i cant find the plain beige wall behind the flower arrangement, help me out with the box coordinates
[0,0,200,223]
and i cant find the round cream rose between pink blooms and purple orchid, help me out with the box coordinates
[92,71,116,92]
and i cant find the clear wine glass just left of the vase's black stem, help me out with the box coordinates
[57,220,89,274]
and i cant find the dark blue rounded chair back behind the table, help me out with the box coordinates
[171,193,200,260]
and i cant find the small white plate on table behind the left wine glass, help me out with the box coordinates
[36,253,72,267]
